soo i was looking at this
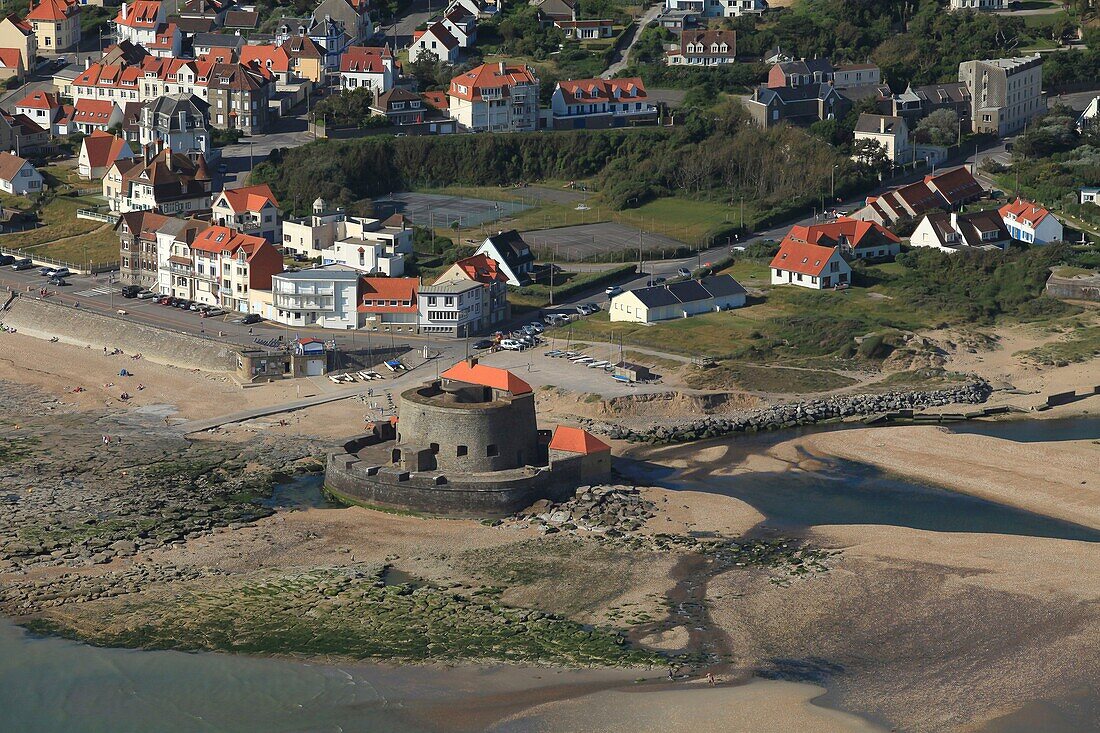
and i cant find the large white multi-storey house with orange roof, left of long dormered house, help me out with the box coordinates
[448,62,539,131]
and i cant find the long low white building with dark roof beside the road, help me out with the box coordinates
[608,270,746,324]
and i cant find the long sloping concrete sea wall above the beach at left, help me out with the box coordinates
[0,295,237,372]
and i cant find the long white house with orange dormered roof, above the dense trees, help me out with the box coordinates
[549,77,657,130]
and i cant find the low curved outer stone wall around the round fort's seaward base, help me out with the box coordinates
[325,453,572,517]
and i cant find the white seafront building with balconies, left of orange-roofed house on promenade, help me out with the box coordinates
[266,264,362,330]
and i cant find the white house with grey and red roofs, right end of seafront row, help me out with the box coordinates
[418,249,512,338]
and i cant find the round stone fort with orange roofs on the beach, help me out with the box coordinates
[325,359,611,516]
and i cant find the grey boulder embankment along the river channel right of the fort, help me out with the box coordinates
[581,382,992,444]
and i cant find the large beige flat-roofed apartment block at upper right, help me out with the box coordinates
[959,54,1046,136]
